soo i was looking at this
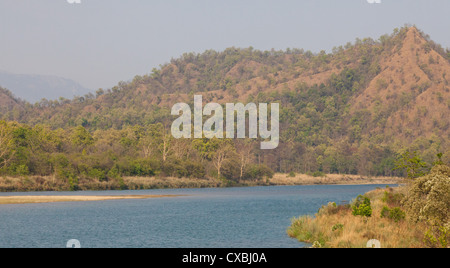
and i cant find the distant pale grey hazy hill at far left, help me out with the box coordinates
[0,71,91,103]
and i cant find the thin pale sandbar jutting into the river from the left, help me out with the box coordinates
[0,195,176,205]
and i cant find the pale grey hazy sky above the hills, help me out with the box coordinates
[0,0,450,89]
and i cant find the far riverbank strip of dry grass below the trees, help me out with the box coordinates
[0,174,402,192]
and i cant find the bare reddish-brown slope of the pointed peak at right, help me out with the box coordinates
[351,27,450,142]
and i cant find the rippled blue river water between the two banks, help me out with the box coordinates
[0,185,392,248]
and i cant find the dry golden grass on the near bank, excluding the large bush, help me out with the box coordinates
[288,189,426,248]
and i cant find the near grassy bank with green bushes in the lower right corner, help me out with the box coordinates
[287,165,450,248]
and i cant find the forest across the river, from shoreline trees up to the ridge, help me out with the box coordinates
[0,27,450,189]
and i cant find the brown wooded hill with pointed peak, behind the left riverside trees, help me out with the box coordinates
[1,27,450,179]
